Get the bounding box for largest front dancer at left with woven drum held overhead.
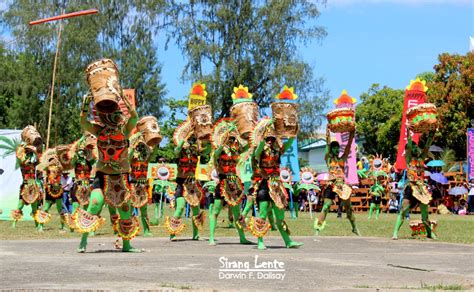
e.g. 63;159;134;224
73;59;141;252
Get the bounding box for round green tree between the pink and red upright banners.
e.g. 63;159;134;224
356;84;404;160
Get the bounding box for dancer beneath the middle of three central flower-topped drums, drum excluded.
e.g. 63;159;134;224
209;119;251;245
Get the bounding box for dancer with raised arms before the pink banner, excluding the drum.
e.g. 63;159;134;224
313;127;360;236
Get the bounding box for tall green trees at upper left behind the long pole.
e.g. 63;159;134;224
0;0;165;145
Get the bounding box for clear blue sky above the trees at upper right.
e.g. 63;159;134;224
159;0;474;107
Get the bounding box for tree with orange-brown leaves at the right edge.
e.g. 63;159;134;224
427;52;474;160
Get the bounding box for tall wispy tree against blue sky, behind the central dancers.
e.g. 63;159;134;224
166;0;327;136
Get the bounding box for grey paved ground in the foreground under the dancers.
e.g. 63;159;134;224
0;237;474;291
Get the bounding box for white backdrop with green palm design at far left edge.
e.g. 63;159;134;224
0;129;32;220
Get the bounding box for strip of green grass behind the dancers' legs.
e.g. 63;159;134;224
0;208;474;244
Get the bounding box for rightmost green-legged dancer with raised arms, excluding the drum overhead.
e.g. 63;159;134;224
392;125;437;240
